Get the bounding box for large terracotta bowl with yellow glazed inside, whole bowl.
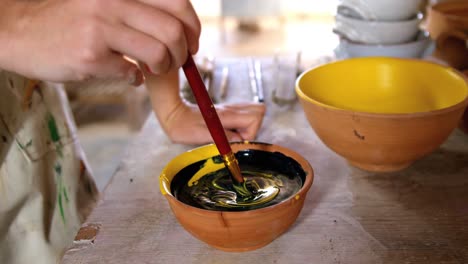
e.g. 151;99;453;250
296;57;468;171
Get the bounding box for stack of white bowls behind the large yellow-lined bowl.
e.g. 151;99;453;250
334;0;431;58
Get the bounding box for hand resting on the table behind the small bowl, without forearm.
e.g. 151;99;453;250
160;102;265;144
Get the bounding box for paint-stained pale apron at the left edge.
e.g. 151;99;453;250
0;70;98;264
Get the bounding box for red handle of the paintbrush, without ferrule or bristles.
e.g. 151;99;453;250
182;55;232;155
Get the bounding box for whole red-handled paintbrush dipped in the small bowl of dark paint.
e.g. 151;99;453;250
182;54;245;187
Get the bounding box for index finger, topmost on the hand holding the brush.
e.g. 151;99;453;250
139;0;201;54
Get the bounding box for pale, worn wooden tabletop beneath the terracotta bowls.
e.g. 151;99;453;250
63;57;468;264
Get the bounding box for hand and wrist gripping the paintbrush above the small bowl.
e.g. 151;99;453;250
0;0;200;82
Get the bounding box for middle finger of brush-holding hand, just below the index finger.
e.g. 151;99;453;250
119;1;188;68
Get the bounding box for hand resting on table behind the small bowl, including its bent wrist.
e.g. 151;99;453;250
145;70;265;144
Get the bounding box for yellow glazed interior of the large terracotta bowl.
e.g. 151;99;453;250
297;58;468;114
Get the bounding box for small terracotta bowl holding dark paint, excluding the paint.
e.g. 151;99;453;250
159;142;314;252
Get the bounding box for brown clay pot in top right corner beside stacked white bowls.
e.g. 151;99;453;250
426;0;468;40
